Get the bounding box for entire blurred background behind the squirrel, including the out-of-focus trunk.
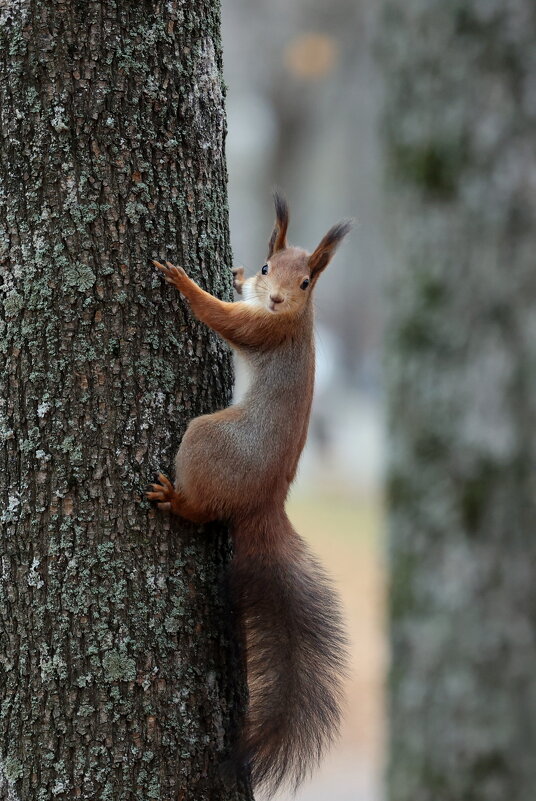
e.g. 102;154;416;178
223;0;536;801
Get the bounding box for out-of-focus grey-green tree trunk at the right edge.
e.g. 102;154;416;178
381;6;536;801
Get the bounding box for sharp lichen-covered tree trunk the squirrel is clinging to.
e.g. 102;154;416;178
0;0;251;801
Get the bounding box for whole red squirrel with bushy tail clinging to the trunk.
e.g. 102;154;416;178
147;194;351;794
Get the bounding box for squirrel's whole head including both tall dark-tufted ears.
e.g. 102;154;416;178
242;192;352;315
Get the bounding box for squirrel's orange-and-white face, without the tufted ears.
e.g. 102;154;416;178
242;247;313;315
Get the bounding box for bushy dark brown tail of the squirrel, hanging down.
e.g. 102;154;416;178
231;514;346;795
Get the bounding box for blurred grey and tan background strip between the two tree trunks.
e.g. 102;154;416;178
223;0;386;801
